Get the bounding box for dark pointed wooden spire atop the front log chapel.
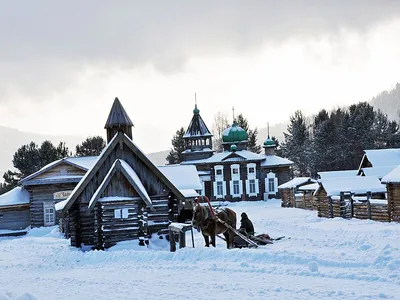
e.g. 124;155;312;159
104;97;133;143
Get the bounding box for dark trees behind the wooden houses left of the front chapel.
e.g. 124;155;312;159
0;136;106;195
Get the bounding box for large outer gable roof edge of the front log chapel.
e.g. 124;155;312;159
63;132;185;214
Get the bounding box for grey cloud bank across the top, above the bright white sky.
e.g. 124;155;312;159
0;0;400;102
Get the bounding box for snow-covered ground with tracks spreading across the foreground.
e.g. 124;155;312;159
0;200;400;300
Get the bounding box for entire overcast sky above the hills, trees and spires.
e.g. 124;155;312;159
0;0;400;152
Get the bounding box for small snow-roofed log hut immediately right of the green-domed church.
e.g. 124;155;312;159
278;177;317;208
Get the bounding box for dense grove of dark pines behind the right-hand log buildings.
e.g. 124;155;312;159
281;102;400;177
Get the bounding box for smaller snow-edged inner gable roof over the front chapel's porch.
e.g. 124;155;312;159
88;159;154;210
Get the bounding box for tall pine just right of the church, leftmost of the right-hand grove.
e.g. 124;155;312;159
281;111;309;176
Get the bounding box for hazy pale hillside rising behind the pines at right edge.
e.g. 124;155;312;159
370;83;400;123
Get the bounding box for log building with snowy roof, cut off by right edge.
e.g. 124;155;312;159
382;165;400;222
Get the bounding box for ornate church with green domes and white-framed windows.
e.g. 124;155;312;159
182;105;293;201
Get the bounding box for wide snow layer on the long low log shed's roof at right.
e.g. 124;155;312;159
319;176;386;196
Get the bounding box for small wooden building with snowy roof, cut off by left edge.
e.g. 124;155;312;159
0;187;30;236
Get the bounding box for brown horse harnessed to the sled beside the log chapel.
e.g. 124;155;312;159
192;204;236;249
